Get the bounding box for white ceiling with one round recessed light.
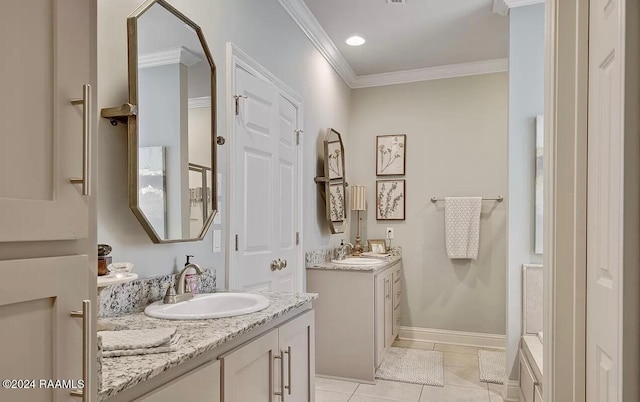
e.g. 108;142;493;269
304;0;509;76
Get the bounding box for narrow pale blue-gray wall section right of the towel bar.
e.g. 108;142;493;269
507;4;544;380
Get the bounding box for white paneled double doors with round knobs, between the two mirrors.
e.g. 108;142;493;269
229;67;299;291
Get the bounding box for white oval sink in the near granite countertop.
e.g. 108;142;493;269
144;293;271;320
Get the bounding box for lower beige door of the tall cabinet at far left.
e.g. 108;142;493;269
0;255;89;402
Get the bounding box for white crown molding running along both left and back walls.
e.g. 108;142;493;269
278;0;510;89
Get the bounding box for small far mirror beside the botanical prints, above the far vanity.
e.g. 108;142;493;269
316;128;347;234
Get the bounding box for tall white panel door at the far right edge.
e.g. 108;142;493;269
586;0;624;402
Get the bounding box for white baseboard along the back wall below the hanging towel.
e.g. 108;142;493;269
398;327;506;349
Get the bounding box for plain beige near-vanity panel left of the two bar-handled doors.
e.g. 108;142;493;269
135;361;220;402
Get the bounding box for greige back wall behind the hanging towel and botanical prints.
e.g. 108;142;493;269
345;73;508;335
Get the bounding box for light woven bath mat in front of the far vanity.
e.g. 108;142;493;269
376;347;444;387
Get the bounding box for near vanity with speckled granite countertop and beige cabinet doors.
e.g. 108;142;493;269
98;292;317;402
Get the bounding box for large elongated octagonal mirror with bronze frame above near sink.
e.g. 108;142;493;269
127;0;217;243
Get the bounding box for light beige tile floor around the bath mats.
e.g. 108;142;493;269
316;341;502;402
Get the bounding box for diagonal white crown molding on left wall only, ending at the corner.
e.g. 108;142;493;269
278;0;356;87
